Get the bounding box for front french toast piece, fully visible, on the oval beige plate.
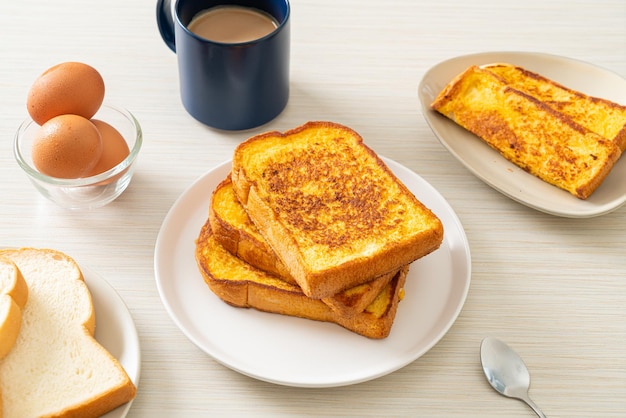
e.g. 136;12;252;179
431;66;621;199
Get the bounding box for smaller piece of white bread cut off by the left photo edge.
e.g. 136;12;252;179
0;257;28;360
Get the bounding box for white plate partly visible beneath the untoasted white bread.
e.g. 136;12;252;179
80;266;141;418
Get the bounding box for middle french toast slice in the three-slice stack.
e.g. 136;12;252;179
209;176;397;316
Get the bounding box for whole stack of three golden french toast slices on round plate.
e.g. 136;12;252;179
195;122;443;339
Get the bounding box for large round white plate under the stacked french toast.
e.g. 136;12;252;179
154;159;471;387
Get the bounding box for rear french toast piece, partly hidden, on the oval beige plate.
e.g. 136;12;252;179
481;63;626;152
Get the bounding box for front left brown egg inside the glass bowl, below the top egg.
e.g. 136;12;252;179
32;115;102;179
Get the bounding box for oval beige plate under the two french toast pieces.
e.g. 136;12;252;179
418;52;626;218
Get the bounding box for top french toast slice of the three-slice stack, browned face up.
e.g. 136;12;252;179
231;122;444;299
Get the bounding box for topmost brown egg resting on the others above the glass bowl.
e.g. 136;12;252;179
26;62;104;125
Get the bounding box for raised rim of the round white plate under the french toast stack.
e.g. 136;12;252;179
154;157;471;388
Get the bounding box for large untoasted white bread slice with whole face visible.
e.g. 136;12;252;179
0;248;136;418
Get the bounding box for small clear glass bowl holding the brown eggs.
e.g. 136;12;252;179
13;104;143;209
